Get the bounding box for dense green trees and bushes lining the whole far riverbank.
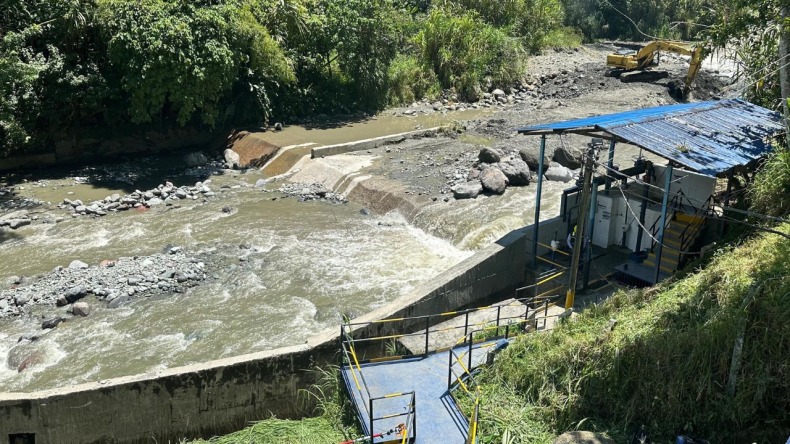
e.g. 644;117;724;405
0;0;779;155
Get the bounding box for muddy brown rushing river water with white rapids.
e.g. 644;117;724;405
0;107;656;391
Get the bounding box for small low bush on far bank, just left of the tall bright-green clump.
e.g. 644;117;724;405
387;54;441;105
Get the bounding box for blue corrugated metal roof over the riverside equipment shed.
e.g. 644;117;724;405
518;99;785;176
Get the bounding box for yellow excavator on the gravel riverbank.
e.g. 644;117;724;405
606;40;703;97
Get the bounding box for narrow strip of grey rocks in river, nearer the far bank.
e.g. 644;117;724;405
58;179;214;217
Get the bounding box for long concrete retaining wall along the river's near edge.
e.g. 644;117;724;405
0;230;527;444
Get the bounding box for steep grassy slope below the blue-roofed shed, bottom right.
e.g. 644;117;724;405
478;224;790;442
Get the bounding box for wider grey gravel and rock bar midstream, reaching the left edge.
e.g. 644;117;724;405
0;247;207;320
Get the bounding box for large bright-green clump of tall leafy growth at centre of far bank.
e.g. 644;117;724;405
415;8;525;100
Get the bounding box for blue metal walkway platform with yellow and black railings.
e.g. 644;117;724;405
341;341;496;444
